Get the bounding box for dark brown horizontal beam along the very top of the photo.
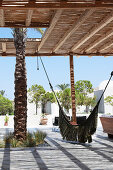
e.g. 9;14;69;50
0;0;113;10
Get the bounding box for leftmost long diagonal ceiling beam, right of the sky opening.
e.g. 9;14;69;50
38;10;62;51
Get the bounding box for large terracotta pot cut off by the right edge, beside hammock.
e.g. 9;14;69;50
100;116;113;138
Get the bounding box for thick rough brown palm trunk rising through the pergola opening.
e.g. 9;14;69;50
14;28;27;140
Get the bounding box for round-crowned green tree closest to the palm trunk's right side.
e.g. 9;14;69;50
28;84;46;114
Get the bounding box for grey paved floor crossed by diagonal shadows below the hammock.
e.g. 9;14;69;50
0;125;113;170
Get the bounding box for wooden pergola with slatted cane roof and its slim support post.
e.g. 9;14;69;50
0;0;113;123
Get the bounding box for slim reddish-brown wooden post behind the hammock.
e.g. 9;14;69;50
70;55;77;124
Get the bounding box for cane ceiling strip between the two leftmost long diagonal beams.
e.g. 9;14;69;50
41;10;84;52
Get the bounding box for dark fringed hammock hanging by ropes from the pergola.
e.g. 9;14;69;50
40;57;113;143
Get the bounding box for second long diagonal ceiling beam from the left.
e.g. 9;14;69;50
53;9;94;52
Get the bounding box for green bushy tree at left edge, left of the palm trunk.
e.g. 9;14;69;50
0;94;13;115
